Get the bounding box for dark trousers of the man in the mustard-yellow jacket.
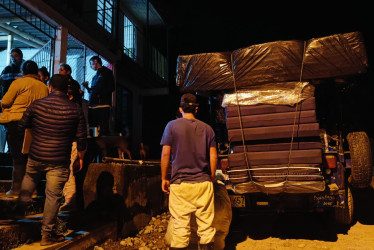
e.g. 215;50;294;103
6;121;27;193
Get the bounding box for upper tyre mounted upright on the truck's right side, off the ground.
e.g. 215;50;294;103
347;132;372;188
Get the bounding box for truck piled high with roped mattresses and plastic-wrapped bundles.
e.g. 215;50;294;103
177;32;372;225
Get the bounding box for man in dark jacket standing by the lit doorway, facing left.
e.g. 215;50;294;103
83;56;115;135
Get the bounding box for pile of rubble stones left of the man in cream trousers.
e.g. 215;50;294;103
94;212;170;250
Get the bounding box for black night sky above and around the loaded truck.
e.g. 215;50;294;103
144;0;374;157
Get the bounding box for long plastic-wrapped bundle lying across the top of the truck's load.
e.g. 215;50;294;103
177;32;368;92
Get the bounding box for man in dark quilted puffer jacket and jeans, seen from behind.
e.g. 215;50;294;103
18;74;87;246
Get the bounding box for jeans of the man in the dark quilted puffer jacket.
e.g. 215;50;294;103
19;158;70;234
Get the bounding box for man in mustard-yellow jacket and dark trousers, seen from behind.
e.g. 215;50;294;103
0;60;48;196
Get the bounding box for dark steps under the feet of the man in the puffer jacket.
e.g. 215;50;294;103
0;212;117;250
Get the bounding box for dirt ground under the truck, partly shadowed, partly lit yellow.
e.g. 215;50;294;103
226;188;374;250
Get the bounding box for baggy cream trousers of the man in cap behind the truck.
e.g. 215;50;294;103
169;181;216;248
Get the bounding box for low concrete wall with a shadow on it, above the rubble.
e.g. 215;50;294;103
83;163;168;235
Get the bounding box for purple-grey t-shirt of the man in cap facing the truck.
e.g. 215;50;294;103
160;118;216;183
